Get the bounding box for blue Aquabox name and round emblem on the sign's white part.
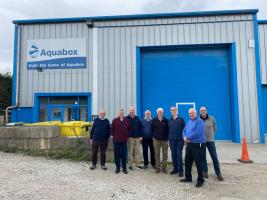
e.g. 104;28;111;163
29;44;78;58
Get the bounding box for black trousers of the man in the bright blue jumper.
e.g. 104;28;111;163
185;143;206;183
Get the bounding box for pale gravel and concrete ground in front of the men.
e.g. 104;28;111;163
0;143;267;200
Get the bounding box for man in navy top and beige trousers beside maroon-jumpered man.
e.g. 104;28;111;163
127;106;143;170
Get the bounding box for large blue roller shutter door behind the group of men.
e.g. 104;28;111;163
140;48;232;140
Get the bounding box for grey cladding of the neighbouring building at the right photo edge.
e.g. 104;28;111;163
259;24;267;84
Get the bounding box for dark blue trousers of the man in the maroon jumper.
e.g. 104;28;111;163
113;142;128;170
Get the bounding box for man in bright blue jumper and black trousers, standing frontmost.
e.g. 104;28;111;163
180;108;206;187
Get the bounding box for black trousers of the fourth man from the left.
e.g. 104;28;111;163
142;138;155;166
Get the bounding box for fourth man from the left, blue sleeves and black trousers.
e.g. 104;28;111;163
142;110;155;169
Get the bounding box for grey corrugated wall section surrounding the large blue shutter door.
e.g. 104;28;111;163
95;15;260;141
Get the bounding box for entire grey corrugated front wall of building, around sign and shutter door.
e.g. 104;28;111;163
19;14;259;141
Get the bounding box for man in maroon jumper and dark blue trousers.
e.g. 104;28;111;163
111;109;131;174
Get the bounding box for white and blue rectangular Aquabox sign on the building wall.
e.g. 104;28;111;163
27;38;86;70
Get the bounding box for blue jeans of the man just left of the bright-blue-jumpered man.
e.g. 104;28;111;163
169;140;184;172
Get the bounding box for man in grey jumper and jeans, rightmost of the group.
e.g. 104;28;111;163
200;106;223;181
